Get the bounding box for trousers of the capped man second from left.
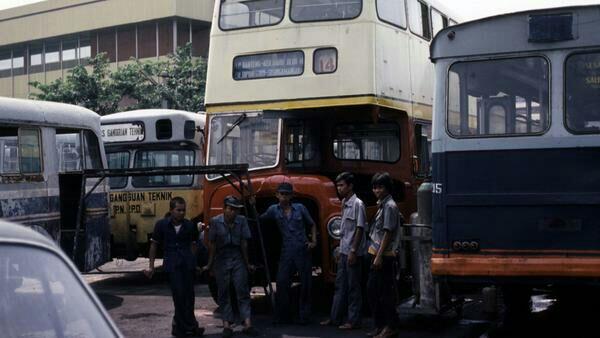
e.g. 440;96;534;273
215;256;250;323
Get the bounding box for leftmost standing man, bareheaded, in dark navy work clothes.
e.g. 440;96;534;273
144;197;204;337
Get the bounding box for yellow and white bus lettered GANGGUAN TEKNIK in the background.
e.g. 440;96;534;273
101;109;205;260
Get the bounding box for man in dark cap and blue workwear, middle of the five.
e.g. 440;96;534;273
260;182;317;324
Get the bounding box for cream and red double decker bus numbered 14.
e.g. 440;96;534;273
204;0;454;281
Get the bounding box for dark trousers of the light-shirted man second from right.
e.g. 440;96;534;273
330;254;362;327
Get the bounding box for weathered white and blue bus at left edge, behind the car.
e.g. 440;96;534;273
0;98;110;271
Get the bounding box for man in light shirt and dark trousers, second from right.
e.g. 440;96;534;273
321;172;366;330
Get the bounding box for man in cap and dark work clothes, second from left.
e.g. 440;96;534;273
203;195;258;337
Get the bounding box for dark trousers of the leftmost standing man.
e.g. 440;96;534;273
169;267;198;333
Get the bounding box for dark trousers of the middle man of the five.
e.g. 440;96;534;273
275;248;312;322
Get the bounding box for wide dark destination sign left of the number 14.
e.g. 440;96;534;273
233;51;304;80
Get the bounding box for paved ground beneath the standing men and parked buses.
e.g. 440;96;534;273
85;259;600;338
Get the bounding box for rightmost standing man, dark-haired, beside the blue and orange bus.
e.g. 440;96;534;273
367;173;401;338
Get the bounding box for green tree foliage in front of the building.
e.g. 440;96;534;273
30;44;206;115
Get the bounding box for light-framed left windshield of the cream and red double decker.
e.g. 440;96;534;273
208;114;279;178
